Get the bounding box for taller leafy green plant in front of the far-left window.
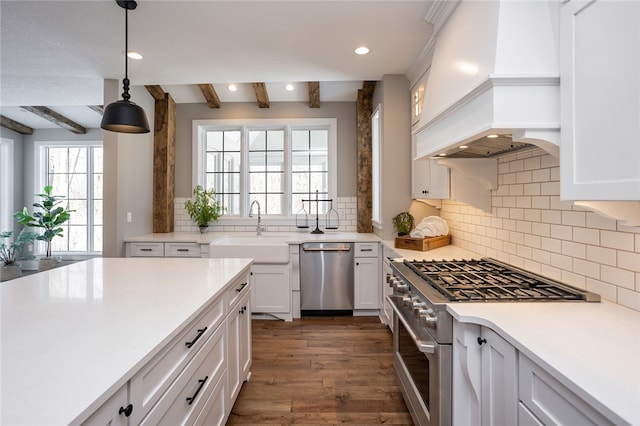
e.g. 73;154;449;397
13;185;73;271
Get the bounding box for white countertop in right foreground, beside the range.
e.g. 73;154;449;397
447;301;640;425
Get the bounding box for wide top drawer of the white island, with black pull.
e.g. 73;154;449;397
131;297;225;424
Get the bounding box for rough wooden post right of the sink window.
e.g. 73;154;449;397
356;81;376;232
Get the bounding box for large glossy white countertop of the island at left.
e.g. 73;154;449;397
0;258;251;426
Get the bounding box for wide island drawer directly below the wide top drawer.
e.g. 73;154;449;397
141;326;226;426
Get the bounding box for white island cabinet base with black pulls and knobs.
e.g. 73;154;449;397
86;274;251;426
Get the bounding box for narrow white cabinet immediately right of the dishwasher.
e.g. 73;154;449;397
353;243;381;314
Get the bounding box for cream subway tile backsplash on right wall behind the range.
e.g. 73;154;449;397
441;149;640;311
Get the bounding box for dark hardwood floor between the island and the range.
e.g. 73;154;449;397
227;317;413;425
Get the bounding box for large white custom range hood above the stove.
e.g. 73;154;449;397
414;0;560;158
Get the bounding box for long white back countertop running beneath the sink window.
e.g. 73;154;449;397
124;231;380;244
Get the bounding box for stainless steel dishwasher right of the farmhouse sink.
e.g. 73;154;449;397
300;243;353;316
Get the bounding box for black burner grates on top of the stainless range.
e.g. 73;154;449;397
404;258;599;302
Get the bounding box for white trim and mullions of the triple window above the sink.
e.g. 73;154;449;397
191;118;338;225
